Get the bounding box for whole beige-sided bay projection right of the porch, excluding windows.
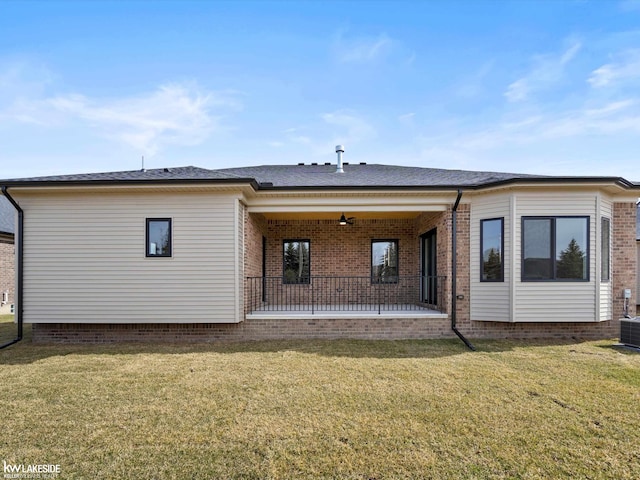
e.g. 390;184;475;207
470;190;616;322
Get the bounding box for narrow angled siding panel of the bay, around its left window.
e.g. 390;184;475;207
470;195;511;322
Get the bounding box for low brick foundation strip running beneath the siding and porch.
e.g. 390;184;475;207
32;318;619;343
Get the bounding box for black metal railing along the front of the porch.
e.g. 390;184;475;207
245;275;446;314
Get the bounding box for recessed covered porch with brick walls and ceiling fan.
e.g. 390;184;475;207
244;192;455;320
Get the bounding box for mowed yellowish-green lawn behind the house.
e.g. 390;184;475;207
0;328;640;479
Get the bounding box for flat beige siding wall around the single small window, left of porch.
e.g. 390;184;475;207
16;189;241;323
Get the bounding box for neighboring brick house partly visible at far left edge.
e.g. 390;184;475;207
0;195;16;314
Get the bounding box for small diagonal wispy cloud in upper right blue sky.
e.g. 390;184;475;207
504;41;582;102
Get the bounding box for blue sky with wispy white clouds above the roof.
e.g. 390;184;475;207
0;0;640;181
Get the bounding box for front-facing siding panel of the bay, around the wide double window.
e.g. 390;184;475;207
514;192;600;322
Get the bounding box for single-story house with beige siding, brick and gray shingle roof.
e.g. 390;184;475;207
0;158;640;342
